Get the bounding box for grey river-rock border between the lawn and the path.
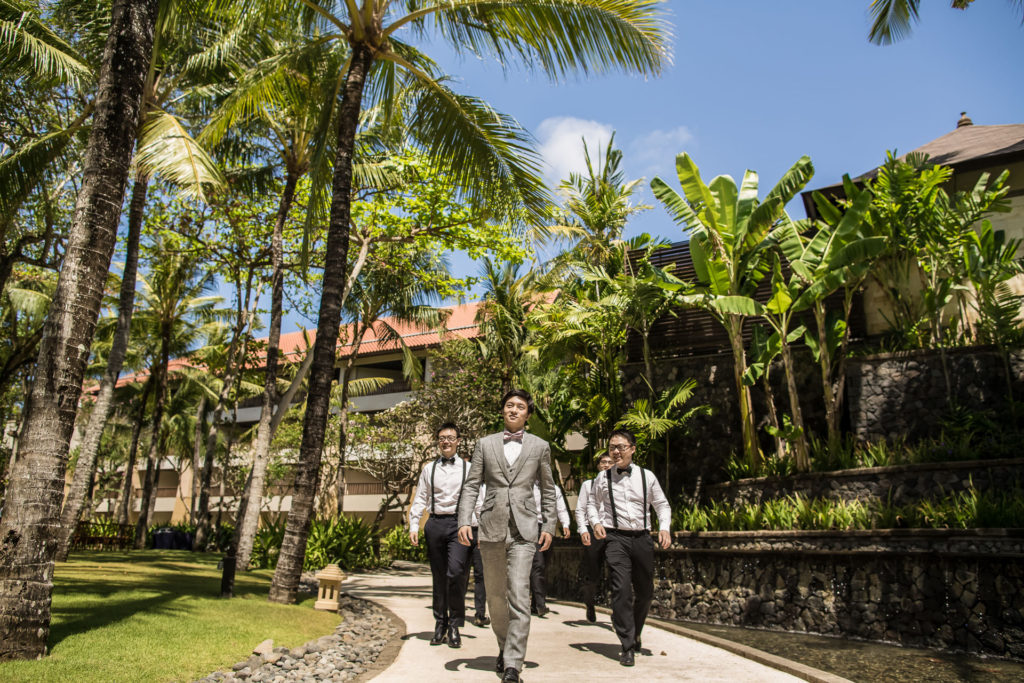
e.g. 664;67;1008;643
199;593;406;683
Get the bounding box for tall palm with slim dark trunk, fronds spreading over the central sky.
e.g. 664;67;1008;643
270;0;666;602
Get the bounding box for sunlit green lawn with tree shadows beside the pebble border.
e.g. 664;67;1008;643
0;550;339;683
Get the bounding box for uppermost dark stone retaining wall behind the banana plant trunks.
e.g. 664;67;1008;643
624;347;1024;496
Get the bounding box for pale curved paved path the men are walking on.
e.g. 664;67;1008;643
342;565;800;683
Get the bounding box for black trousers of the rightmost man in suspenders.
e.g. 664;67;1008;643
604;529;654;650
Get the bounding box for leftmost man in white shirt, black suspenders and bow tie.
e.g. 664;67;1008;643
409;422;469;647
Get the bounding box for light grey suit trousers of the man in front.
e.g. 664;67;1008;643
480;531;537;671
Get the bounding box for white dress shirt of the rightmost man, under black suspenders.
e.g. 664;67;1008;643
587;464;672;531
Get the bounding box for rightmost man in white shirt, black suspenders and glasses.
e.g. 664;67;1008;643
587;429;672;667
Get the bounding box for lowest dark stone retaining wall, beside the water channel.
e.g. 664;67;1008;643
547;529;1024;659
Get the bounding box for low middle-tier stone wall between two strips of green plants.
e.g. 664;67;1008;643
706;458;1024;505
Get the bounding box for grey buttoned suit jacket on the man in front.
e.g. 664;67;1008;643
459;432;556;543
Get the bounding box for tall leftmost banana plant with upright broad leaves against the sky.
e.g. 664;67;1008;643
650;153;814;472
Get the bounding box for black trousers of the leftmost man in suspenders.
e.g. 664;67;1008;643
423;515;469;627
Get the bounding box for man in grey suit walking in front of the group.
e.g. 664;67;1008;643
459;389;556;683
